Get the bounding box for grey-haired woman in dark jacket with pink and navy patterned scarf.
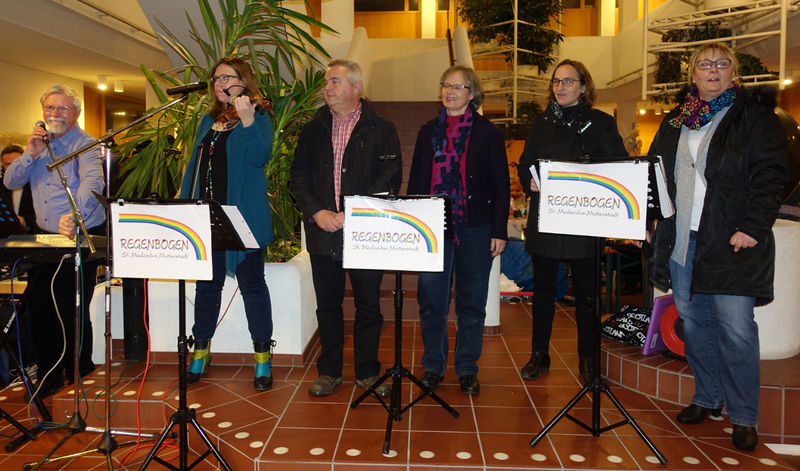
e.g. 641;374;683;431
408;66;510;394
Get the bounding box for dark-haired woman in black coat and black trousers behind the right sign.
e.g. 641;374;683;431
518;59;627;382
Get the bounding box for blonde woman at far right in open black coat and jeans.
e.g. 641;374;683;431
649;43;788;451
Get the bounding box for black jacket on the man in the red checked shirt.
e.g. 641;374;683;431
291;99;403;259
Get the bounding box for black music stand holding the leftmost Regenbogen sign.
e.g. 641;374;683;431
126;199;245;471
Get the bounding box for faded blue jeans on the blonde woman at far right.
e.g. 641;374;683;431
669;232;760;427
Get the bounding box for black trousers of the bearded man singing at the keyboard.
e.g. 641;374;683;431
24;258;100;387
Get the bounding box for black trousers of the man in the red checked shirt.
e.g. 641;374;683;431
311;255;383;379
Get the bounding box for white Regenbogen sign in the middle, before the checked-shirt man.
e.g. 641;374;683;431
343;196;444;272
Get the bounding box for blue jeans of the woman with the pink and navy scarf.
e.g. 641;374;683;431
417;224;492;376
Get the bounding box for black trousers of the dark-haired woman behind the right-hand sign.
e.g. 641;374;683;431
531;254;595;358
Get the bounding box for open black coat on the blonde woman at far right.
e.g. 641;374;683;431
648;87;788;305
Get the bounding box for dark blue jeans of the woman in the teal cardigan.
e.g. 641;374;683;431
192;250;272;342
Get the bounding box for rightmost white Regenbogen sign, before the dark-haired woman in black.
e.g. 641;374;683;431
539;160;648;240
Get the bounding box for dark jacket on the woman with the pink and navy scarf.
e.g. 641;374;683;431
408;112;510;240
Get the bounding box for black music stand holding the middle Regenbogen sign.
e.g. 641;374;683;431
350;195;459;454
